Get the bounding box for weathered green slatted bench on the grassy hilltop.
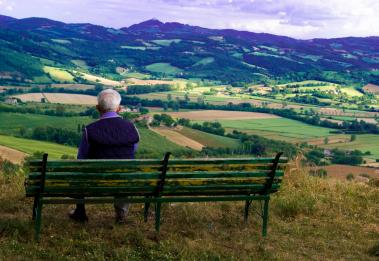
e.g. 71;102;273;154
25;153;287;240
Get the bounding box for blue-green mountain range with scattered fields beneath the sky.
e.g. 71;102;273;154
0;13;379;85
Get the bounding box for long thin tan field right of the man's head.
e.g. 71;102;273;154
167;110;280;121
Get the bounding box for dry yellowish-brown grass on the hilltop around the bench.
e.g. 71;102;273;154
0;162;379;261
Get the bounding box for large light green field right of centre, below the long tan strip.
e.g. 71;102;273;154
215;118;330;138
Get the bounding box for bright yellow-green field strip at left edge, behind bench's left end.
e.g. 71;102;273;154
0;135;78;159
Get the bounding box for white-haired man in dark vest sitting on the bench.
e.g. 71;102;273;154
69;89;139;224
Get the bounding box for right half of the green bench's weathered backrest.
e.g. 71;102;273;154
162;154;287;196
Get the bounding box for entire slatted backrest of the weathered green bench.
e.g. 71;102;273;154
26;154;287;197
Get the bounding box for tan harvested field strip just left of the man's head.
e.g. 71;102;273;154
14;93;97;105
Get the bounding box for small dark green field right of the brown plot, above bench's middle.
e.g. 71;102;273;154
178;127;240;148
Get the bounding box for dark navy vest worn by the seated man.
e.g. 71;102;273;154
86;117;139;159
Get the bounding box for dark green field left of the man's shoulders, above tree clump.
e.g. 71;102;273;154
0;112;93;135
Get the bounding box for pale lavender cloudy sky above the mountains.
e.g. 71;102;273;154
0;0;379;39
